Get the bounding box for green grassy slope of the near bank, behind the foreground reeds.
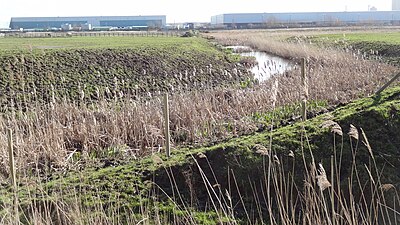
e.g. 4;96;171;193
3;87;400;223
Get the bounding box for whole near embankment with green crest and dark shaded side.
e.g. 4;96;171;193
2;84;400;223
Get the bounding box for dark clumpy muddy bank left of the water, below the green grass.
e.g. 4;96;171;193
0;47;250;105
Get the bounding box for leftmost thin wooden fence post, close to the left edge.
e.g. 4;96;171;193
7;129;19;224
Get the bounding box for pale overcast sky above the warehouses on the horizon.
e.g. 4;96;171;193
0;0;392;27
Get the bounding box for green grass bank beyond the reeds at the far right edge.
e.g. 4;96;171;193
311;32;400;66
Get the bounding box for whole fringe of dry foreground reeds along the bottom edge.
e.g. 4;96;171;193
0;110;400;225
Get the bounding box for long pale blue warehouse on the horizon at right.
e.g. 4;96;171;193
211;11;400;28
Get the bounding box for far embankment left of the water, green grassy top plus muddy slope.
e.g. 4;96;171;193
0;37;250;106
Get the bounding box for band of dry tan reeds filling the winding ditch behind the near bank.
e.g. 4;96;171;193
0;30;395;178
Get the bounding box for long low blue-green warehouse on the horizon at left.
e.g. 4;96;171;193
10;15;166;30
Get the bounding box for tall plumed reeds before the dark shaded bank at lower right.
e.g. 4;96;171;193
161;96;400;224
